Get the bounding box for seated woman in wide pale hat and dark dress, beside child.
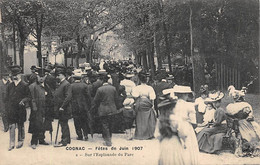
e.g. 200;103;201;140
197;91;227;153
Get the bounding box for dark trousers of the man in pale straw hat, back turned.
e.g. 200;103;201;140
73;115;88;138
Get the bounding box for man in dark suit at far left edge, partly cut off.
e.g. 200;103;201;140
0;73;10;132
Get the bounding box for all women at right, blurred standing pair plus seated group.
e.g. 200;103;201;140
158;85;260;164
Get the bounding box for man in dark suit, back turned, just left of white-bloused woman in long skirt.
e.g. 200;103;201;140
94;73;118;146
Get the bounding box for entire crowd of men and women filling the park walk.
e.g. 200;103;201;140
0;61;260;164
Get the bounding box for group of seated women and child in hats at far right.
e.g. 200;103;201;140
195;86;260;157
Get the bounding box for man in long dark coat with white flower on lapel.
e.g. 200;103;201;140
29;68;53;149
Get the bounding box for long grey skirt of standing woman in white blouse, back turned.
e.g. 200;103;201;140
135;98;156;140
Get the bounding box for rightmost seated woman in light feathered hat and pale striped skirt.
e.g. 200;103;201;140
226;86;260;156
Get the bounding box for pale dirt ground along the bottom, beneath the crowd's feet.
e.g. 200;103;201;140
0;94;260;165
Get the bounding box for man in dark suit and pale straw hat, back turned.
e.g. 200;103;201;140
71;75;91;140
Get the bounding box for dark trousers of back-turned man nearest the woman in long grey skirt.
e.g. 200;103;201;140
101;116;113;143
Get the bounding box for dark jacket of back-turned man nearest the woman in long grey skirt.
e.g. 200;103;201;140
94;83;119;116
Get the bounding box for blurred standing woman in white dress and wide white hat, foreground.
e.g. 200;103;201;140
159;85;199;165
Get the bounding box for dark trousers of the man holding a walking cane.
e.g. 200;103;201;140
60;119;70;145
